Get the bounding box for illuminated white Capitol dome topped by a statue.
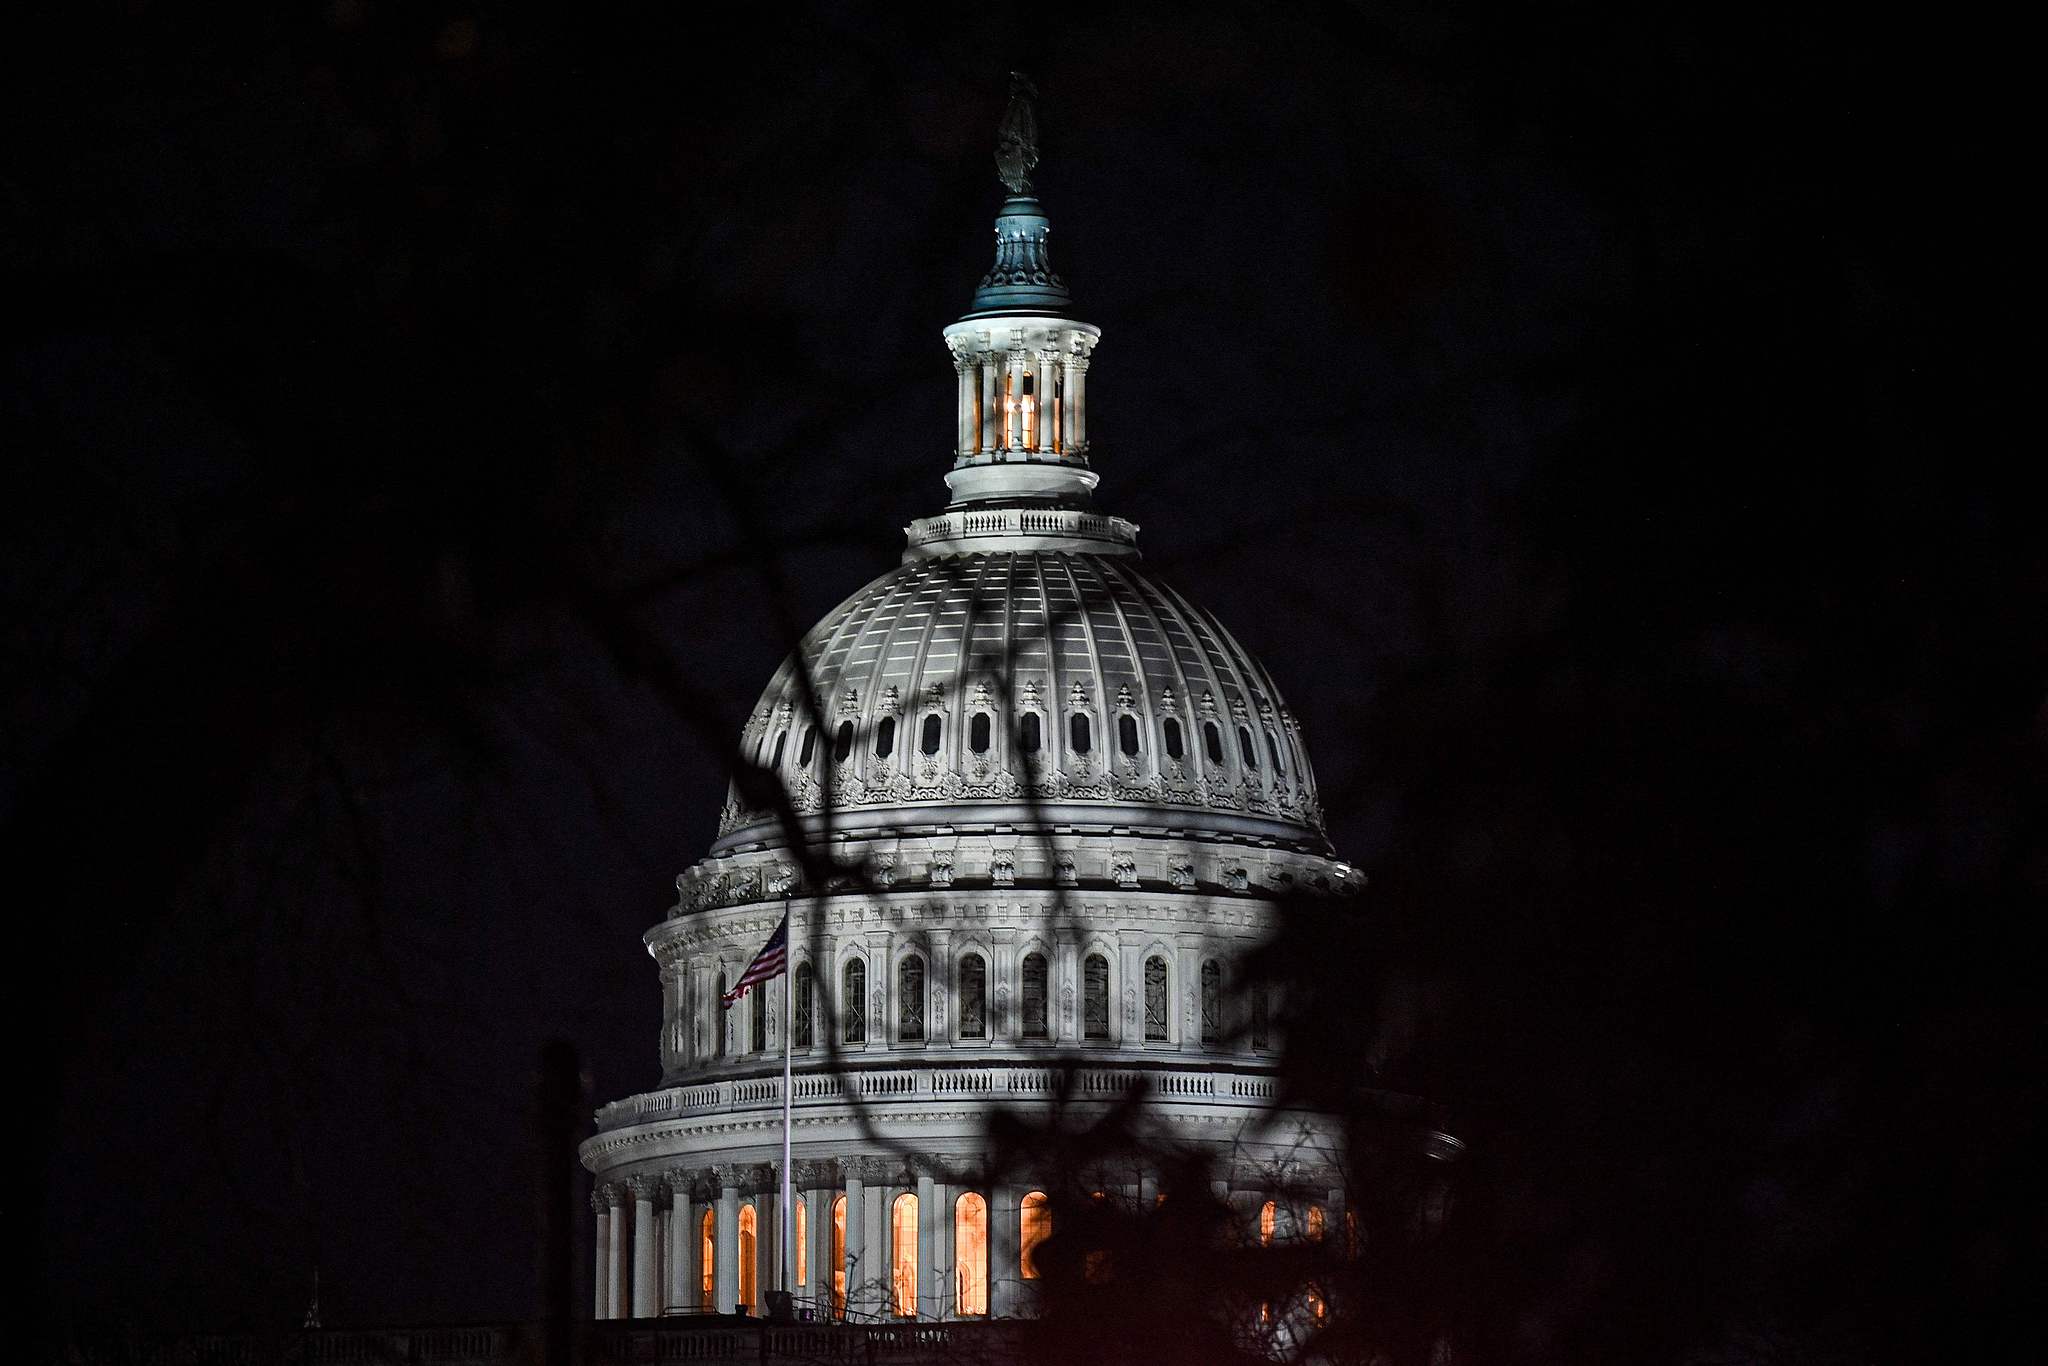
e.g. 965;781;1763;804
582;82;1409;1319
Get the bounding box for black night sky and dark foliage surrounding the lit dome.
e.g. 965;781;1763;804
0;0;2048;1362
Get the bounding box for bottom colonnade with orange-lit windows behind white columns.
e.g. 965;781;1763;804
592;1157;1356;1319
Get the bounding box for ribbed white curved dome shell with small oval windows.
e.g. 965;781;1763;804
721;551;1321;844
